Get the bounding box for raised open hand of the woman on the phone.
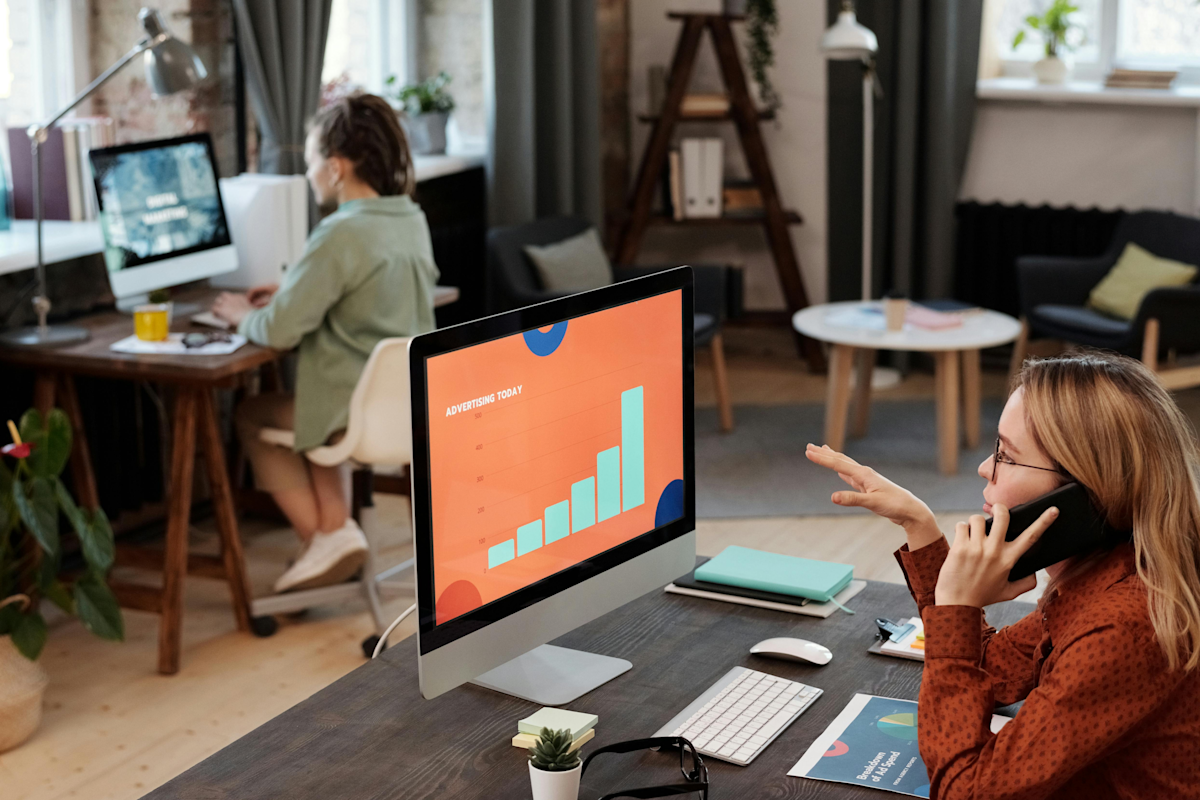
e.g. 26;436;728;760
804;444;942;549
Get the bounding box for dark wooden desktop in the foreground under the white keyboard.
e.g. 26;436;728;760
146;582;1033;800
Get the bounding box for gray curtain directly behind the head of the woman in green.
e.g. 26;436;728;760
233;0;334;175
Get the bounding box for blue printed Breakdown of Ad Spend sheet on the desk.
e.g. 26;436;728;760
787;694;1010;798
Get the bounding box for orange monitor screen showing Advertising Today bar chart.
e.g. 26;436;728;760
427;290;684;625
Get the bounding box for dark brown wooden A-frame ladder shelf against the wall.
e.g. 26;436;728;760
616;12;824;372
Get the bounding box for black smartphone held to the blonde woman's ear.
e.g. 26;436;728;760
988;481;1133;581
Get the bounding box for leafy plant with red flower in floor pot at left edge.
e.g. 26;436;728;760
0;409;125;752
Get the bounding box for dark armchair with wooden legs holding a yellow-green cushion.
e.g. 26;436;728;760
1013;211;1200;389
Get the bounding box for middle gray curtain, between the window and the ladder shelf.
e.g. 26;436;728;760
486;0;602;227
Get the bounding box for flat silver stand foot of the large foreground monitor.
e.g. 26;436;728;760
472;644;634;705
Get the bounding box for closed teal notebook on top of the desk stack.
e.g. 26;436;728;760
695;546;854;603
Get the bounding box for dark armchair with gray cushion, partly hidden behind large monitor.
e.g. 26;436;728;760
487;217;742;432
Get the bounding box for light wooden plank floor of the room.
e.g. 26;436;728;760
0;331;1142;800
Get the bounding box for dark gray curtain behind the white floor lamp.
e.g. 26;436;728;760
828;0;983;300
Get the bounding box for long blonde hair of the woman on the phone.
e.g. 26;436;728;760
1018;350;1200;670
